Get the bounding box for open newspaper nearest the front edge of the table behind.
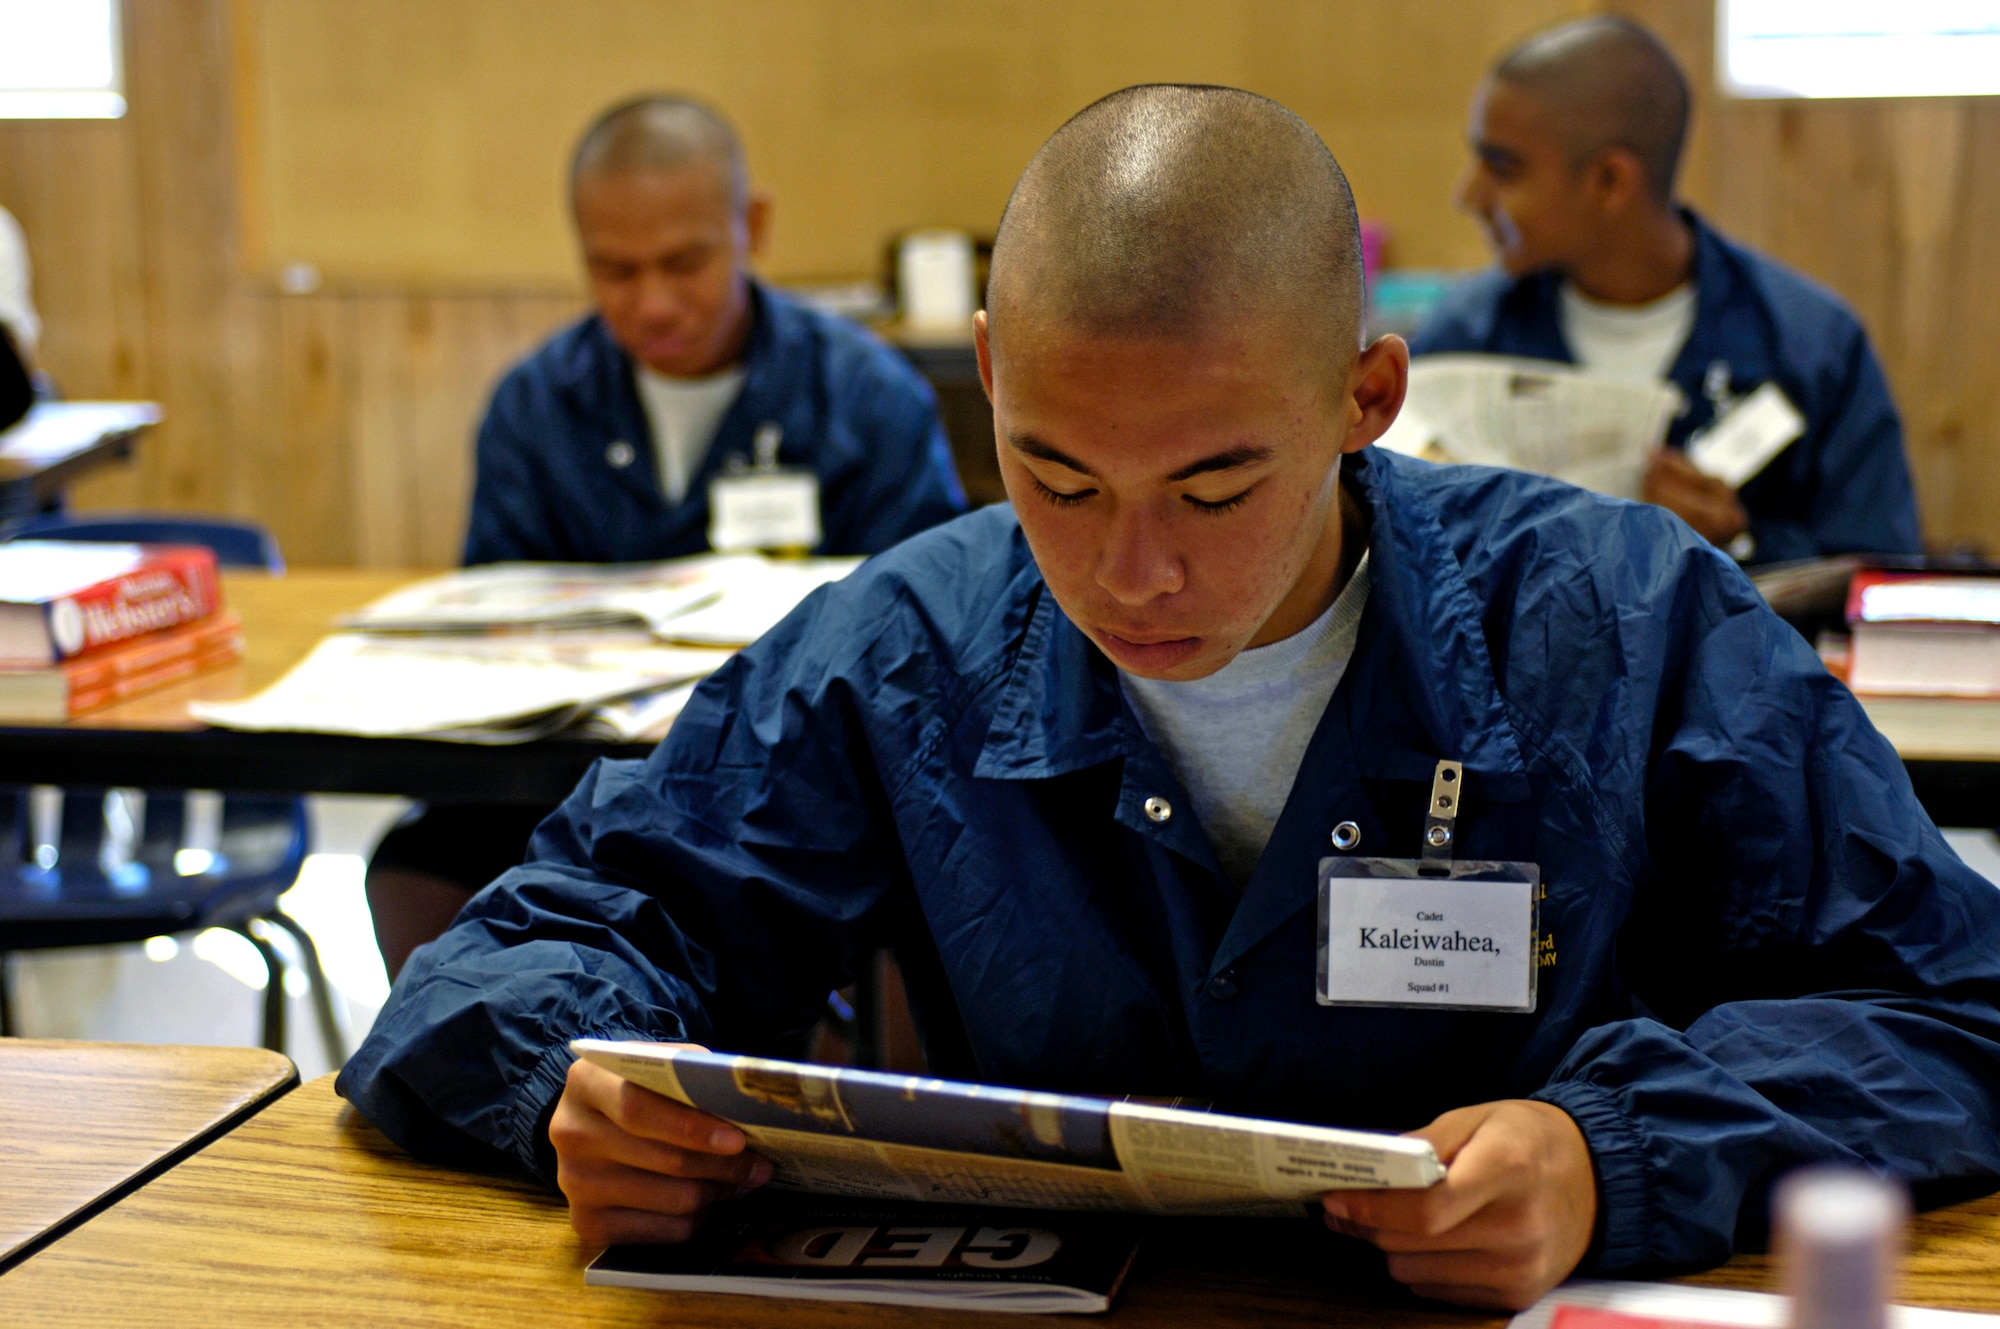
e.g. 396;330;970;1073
188;632;732;743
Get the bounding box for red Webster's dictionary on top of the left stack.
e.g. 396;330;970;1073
0;540;222;667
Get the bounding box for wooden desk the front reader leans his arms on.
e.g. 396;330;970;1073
0;1077;2000;1329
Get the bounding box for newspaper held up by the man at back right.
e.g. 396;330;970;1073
1376;354;1682;498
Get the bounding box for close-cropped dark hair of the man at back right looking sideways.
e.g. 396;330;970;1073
1494;16;1688;202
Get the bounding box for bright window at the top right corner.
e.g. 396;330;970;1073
1716;0;2000;96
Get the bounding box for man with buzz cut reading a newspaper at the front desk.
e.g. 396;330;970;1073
340;86;2000;1307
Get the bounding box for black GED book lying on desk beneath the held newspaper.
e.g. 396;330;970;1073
584;1193;1144;1315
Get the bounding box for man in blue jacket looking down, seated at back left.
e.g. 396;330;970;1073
368;96;966;975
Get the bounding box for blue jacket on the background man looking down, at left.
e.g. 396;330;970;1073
464;282;966;564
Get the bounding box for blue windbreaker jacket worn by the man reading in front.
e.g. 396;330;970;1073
340;448;2000;1271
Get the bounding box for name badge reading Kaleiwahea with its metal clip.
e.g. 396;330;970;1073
1314;761;1542;1013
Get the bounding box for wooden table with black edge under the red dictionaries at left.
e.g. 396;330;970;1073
0;568;652;805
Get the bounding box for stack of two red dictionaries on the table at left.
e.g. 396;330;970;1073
0;540;242;721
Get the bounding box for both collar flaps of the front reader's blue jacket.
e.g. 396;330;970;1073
974;448;1528;799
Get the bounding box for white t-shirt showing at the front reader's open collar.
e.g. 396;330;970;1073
1118;554;1368;891
